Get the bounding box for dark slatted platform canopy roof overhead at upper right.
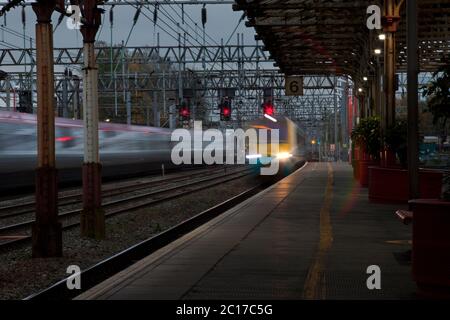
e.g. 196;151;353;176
233;0;450;75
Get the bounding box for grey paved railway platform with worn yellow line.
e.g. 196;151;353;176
76;163;416;300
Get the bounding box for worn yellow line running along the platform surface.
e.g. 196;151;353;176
303;163;333;299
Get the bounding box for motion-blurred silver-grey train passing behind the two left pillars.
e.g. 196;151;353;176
0;111;178;190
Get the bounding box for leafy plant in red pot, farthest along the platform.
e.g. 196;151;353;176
351;117;381;187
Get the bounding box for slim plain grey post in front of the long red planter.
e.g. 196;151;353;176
406;0;419;199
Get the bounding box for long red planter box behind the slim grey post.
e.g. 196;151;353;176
369;167;442;203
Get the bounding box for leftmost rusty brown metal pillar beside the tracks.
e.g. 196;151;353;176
32;0;62;258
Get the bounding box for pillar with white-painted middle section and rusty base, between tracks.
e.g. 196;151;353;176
81;0;105;239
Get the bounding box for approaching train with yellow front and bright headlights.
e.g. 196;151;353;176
247;116;306;176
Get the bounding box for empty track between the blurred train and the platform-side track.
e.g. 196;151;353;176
0;168;253;250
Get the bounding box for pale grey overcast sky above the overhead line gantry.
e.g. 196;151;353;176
0;0;255;47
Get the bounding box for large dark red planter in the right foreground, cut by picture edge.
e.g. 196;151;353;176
409;199;450;298
